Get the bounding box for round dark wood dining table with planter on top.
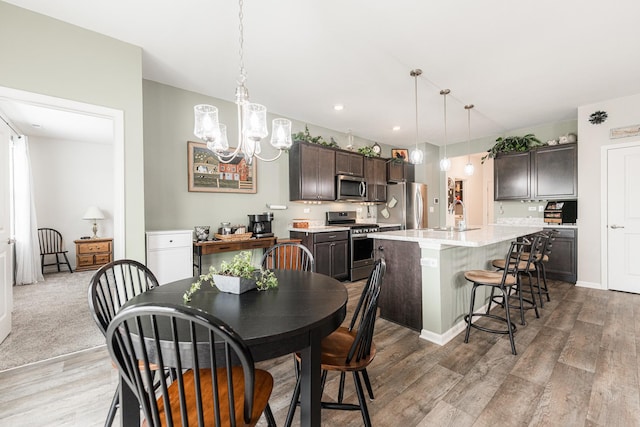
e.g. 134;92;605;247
119;270;347;427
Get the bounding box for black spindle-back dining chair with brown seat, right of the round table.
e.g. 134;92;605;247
285;258;386;427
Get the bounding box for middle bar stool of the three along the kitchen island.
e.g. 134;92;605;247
488;234;542;325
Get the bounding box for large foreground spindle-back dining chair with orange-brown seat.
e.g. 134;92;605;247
107;303;273;426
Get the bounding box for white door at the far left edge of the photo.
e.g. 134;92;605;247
0;126;13;343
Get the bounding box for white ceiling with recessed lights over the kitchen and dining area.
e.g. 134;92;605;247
0;0;640;147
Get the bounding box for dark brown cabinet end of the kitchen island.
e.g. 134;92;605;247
374;239;422;331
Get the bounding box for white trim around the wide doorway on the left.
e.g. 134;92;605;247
0;86;126;259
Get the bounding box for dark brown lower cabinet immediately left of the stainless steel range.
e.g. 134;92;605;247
289;231;349;280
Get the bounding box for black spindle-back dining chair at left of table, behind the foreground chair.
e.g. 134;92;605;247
88;259;158;426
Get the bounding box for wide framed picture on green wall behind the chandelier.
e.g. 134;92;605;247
187;141;258;193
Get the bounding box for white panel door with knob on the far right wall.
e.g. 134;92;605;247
607;145;640;293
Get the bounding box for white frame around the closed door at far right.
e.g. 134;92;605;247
600;139;640;290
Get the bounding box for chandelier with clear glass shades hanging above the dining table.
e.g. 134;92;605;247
193;0;292;164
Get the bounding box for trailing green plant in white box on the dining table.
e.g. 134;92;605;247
183;251;278;302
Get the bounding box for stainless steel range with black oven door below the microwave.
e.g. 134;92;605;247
326;211;378;282
